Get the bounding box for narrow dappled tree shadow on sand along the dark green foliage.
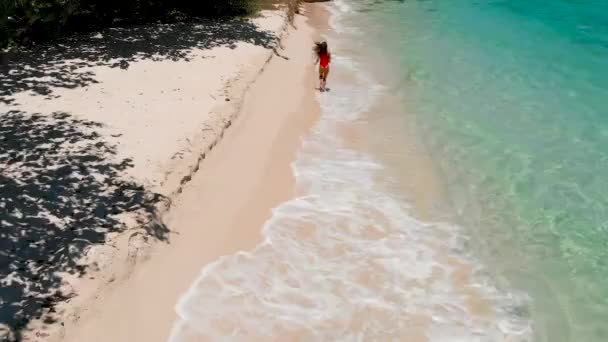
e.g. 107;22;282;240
0;18;277;104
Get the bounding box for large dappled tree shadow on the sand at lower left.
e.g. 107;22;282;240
0;111;169;340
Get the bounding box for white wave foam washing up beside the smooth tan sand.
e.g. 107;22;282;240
170;11;530;342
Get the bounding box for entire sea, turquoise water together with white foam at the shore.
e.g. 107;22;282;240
167;0;608;342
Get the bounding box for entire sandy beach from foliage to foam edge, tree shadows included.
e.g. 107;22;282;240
0;2;318;341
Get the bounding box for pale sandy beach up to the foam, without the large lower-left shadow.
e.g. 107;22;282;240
0;5;318;341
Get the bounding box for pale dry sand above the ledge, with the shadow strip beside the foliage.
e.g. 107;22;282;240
0;11;286;195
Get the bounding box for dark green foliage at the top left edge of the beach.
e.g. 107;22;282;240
0;0;258;48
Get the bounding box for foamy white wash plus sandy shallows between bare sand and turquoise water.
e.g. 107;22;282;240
163;2;532;336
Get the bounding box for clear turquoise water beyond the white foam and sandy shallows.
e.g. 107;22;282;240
340;0;608;341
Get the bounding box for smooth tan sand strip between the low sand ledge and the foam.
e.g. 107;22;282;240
51;5;319;341
